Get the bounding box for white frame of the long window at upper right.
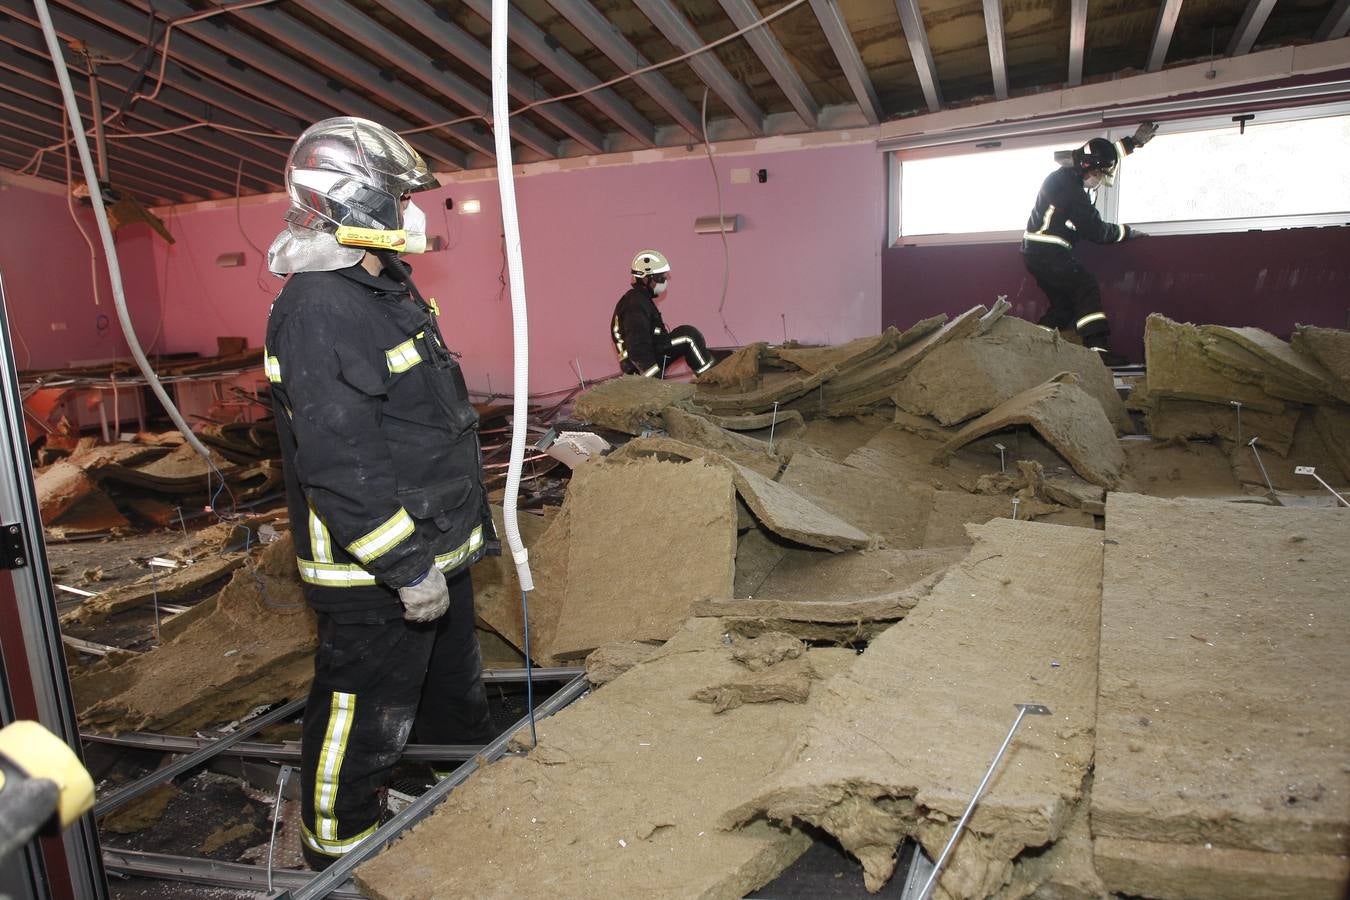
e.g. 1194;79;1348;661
887;101;1350;247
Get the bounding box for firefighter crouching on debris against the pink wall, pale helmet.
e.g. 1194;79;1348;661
609;250;717;378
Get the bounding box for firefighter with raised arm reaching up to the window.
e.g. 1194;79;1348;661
1022;121;1157;364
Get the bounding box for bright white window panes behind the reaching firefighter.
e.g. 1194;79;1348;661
892;109;1350;242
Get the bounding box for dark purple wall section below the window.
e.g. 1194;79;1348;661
882;227;1350;362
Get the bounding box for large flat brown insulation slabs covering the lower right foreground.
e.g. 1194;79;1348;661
358;494;1350;900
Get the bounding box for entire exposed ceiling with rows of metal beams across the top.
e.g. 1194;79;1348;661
0;0;1350;204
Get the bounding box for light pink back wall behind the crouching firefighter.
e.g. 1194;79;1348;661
157;144;886;393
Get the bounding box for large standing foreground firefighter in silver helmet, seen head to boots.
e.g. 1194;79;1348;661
265;117;494;868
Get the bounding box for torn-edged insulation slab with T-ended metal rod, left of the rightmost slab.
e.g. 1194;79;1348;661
724;519;1102;897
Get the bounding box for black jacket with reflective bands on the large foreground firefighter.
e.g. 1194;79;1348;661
265;264;494;615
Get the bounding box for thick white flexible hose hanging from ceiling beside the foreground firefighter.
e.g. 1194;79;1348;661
494;0;535;591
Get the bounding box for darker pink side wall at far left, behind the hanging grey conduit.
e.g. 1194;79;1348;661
0;177;163;368
